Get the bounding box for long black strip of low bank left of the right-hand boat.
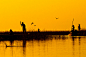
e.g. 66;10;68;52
0;31;69;40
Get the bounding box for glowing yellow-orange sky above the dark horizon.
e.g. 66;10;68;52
0;0;86;31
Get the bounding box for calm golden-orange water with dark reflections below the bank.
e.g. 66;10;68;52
0;35;86;57
